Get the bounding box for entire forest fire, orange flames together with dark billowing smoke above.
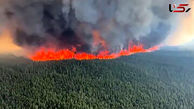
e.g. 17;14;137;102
0;0;172;61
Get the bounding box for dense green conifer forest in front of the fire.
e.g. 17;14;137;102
0;51;194;109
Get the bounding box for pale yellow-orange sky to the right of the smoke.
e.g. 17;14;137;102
166;0;194;46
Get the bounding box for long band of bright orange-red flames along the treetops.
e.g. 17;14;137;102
29;44;159;61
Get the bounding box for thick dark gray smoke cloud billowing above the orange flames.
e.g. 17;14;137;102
0;0;176;52
